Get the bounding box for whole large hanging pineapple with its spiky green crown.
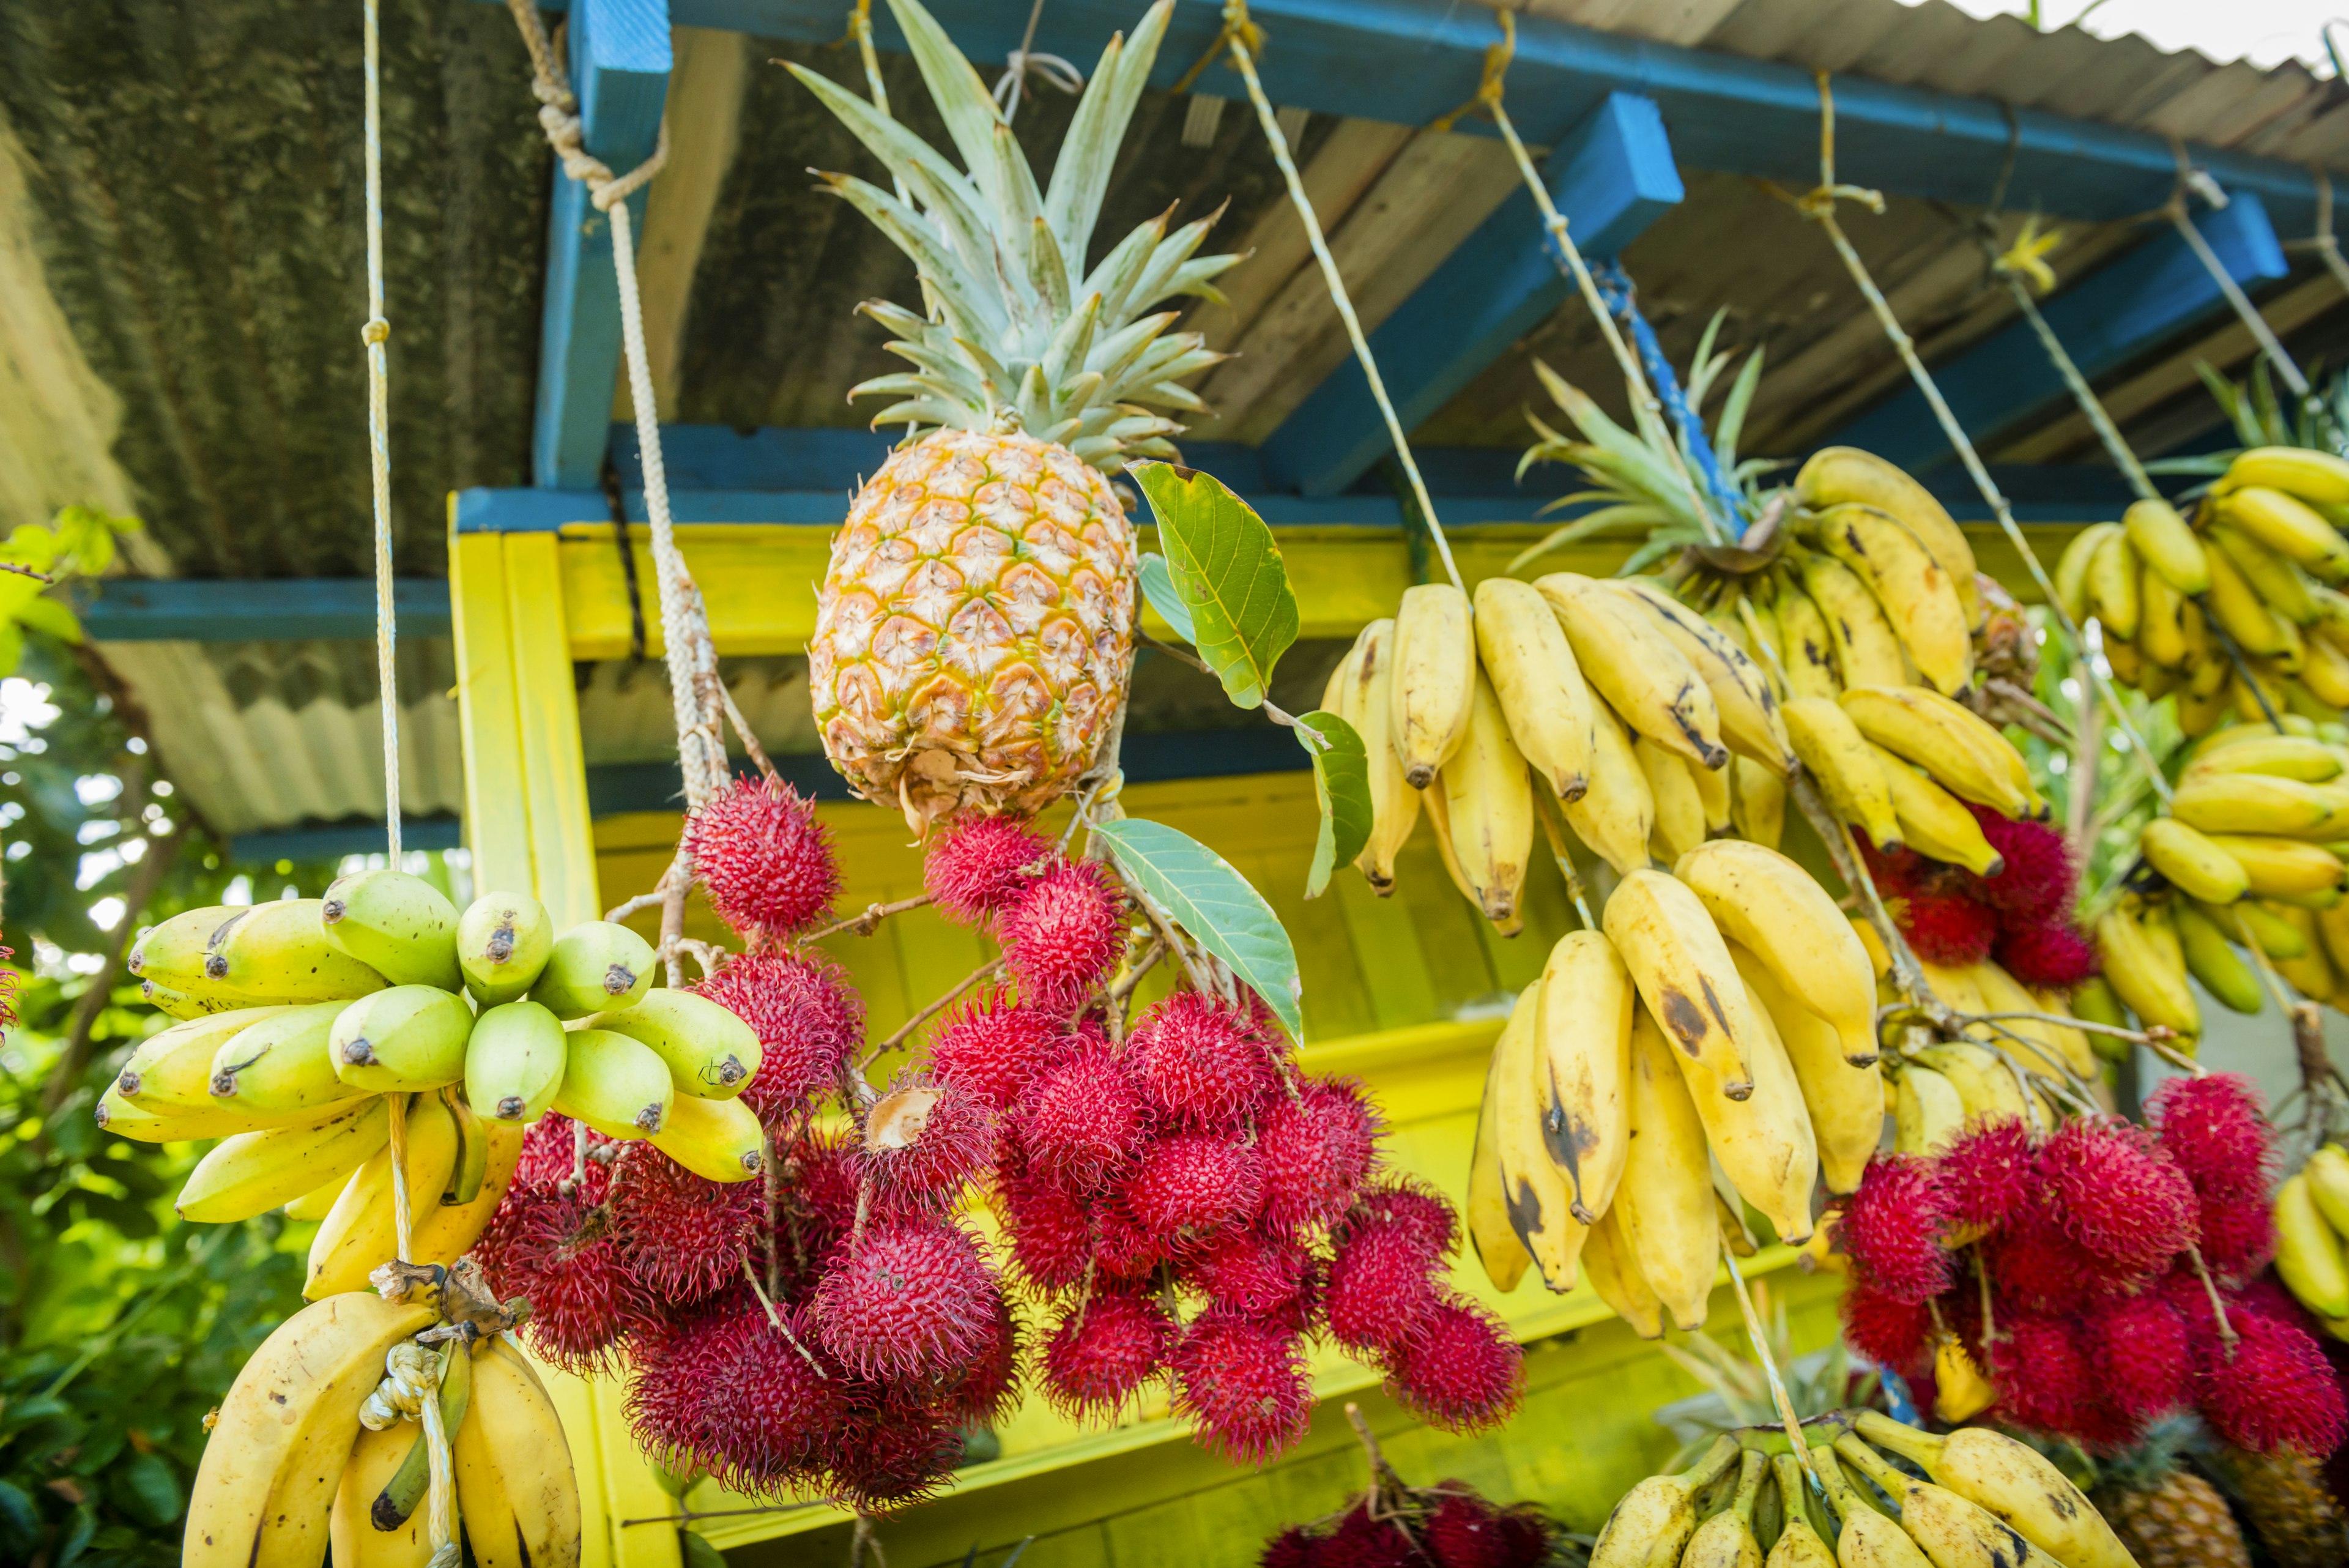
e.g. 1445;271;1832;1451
792;0;1238;832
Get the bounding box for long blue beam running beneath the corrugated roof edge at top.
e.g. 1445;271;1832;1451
472;0;2316;232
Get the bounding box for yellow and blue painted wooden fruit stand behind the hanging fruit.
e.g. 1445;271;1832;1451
37;0;2349;1568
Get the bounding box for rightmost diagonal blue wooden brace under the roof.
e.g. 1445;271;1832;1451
1820;190;2290;468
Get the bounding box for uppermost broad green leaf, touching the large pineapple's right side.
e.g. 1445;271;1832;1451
1127;463;1297;708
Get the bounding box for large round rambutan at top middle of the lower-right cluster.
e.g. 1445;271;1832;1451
2039;1117;2196;1286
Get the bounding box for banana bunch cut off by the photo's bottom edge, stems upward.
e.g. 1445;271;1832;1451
1590;1411;2133;1568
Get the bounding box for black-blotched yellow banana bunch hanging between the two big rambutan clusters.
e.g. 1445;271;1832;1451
1468;839;1884;1337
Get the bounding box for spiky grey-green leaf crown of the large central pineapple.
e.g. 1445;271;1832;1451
789;0;1238;470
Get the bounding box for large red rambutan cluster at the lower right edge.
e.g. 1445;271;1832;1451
1837;1077;2349;1455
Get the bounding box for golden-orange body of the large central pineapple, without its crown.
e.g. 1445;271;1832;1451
808;430;1137;830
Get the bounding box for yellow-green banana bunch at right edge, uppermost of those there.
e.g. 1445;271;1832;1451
2055;447;2349;736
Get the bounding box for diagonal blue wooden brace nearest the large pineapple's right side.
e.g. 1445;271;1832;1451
1264;92;1682;496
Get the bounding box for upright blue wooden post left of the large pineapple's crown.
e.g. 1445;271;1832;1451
531;0;672;489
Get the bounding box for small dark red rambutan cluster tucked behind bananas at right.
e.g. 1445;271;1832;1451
1860;804;2098;987
